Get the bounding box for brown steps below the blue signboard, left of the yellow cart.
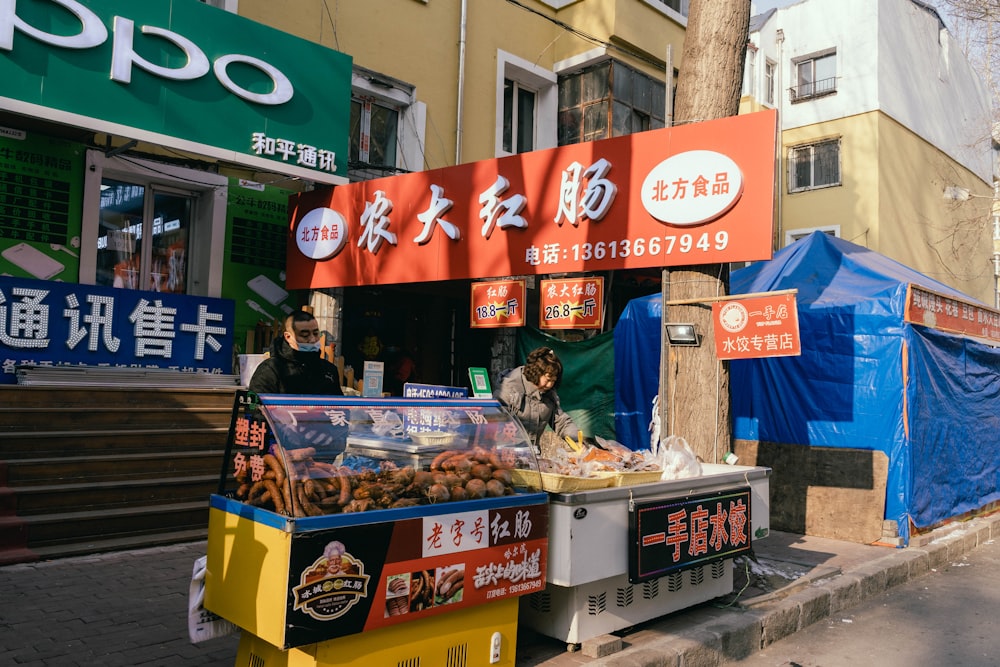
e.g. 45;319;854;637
0;385;238;565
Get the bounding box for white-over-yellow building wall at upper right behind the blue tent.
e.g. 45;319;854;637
741;0;995;304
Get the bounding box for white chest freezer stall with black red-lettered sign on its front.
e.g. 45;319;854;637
521;464;771;648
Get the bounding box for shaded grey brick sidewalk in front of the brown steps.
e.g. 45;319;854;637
0;542;239;667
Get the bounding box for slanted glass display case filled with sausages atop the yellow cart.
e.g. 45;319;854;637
219;392;541;517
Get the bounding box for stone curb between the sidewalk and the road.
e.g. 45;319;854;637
581;514;1000;667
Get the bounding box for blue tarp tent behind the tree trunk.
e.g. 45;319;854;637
615;232;1000;541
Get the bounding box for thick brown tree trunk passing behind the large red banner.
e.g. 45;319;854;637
660;0;750;463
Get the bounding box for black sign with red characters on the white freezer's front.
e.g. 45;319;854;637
628;488;750;584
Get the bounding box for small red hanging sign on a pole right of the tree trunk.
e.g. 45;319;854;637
712;293;802;359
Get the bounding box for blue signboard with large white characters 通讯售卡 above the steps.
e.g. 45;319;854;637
0;277;235;384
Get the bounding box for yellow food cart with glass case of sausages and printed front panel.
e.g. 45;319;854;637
205;392;548;667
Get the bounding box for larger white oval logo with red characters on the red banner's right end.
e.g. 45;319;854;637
642;151;743;227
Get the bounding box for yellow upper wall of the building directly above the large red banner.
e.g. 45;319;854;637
238;0;683;169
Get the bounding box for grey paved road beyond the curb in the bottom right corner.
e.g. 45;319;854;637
728;539;1000;667
